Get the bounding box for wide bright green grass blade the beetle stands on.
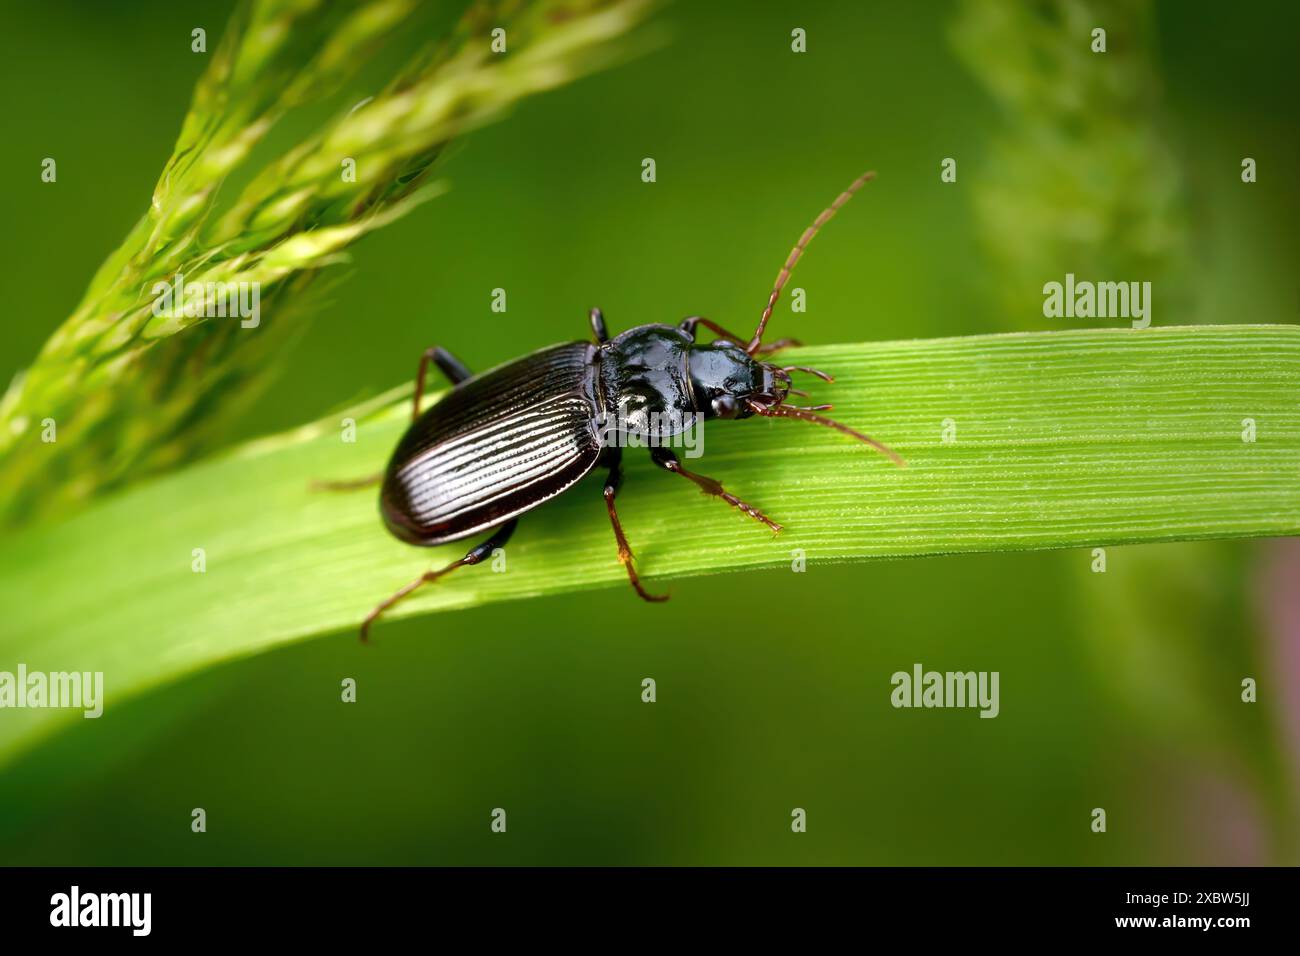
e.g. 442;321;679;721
0;325;1300;756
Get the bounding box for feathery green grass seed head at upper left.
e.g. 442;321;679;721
0;0;650;527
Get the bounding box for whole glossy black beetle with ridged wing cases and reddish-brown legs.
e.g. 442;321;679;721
319;173;904;640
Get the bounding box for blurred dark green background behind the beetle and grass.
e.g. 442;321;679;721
0;0;1300;864
